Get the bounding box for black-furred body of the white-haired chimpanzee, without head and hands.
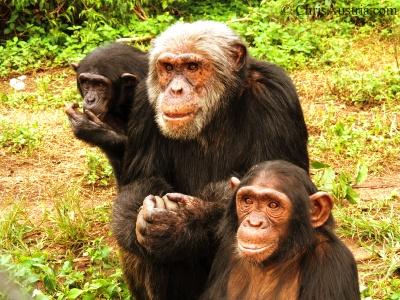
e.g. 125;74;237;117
113;58;309;300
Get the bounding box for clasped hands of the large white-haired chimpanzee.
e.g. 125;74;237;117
136;193;202;253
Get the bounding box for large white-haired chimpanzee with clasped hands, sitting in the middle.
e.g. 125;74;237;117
113;21;308;300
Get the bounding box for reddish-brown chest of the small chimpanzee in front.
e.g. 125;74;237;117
227;257;299;300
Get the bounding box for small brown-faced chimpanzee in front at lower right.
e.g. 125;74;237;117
201;161;360;300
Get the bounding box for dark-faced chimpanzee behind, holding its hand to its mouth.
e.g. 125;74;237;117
66;43;148;181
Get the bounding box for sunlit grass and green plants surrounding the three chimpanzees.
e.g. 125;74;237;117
0;0;400;300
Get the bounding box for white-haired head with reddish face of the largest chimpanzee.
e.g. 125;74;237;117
147;24;247;139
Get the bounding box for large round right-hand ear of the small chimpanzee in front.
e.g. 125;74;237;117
310;192;333;228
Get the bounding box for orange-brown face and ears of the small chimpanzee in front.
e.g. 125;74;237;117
231;170;333;263
